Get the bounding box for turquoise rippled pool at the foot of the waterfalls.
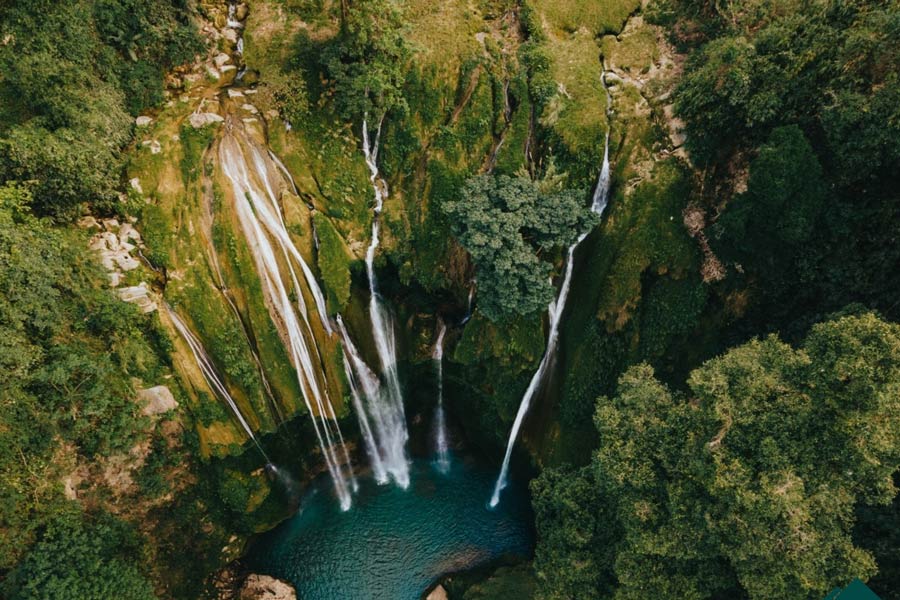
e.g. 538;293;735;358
248;460;534;600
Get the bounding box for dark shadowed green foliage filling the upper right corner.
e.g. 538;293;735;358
651;0;900;339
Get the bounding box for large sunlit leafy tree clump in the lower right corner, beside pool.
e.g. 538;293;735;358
533;313;900;599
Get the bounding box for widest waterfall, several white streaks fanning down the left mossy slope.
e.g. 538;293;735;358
219;129;357;510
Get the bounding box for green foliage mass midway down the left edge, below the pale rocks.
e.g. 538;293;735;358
0;186;162;568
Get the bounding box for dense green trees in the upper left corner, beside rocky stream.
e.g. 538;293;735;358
0;0;202;219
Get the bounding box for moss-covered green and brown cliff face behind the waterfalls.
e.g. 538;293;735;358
85;0;699;592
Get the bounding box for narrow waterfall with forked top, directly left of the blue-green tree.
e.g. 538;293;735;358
362;117;409;488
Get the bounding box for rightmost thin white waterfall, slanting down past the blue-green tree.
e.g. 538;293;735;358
490;67;612;507
